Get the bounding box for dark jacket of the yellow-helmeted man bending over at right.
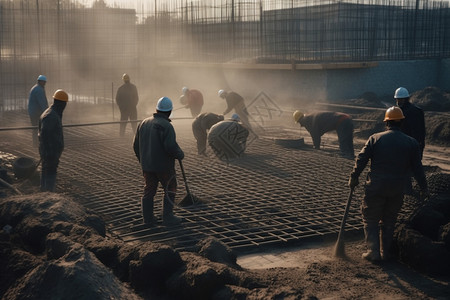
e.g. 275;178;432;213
300;112;351;149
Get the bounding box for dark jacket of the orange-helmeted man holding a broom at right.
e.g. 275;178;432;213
351;127;427;189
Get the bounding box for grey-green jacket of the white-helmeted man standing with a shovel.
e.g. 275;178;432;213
133;113;184;173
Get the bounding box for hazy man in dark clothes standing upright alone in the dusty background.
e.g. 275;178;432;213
116;73;139;137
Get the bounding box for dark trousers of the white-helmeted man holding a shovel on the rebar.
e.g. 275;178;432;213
141;170;177;223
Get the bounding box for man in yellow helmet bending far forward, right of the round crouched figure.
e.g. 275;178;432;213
293;110;355;159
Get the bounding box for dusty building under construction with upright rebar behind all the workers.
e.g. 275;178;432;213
0;0;450;111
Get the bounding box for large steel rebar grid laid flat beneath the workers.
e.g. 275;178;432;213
0;109;370;251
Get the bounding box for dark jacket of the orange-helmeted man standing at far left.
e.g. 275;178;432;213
39;101;66;160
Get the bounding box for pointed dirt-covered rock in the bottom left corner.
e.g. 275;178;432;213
2;244;141;300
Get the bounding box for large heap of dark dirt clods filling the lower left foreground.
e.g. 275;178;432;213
0;193;302;299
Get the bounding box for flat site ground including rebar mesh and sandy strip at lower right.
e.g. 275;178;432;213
0;105;450;299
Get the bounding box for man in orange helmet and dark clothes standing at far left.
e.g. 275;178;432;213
39;90;69;192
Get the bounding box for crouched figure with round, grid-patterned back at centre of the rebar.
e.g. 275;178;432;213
208;114;249;161
